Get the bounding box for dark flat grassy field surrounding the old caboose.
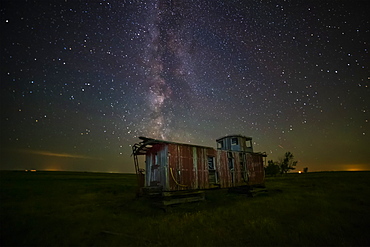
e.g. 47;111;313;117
0;171;370;246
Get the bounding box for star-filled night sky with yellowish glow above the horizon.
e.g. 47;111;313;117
0;0;370;172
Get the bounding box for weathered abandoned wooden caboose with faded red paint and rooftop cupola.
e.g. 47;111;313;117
132;135;266;205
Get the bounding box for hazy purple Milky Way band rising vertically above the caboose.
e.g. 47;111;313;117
144;1;196;139
